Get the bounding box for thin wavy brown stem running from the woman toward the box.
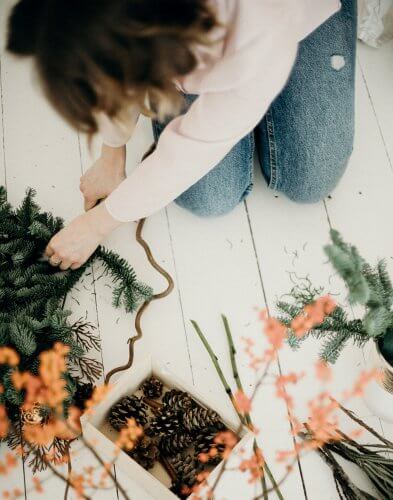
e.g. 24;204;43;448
105;145;174;384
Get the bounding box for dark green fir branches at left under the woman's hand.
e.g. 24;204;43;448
0;186;152;419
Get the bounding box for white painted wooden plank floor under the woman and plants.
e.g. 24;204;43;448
0;2;393;500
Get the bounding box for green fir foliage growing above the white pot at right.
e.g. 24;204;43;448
277;230;393;363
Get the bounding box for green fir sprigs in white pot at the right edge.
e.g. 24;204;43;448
277;230;393;422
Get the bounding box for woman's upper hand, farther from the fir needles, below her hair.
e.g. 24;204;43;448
80;144;126;211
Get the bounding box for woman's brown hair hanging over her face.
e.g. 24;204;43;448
7;0;216;134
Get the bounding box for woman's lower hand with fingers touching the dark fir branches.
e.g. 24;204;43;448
45;203;121;271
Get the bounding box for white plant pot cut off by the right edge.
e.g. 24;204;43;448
364;341;393;423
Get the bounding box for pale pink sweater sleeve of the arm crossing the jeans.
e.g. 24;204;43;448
105;39;297;222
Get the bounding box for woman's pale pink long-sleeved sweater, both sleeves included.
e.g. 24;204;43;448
99;0;340;222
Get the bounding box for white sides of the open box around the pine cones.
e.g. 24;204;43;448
81;359;255;500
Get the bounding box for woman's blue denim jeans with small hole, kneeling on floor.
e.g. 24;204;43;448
153;0;357;216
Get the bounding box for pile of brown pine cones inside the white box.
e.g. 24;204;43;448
108;376;231;498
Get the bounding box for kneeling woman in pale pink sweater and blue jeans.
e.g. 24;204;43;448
8;0;356;269
